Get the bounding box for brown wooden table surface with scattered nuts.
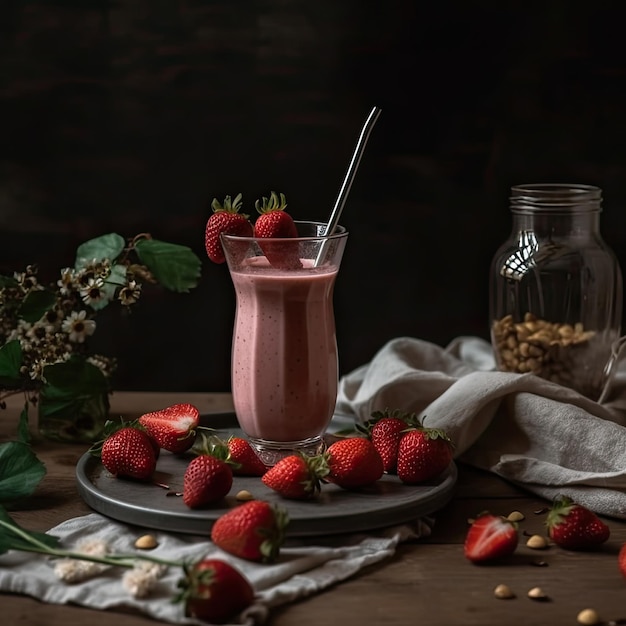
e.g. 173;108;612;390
0;392;626;626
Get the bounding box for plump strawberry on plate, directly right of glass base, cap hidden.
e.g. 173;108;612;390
325;437;384;489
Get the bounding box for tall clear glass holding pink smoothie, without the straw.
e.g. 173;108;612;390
221;222;348;465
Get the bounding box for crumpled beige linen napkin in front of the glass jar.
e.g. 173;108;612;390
337;337;626;518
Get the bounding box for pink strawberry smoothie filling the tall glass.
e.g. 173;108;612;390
231;257;337;442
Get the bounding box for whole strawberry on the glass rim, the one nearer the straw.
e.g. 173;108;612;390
254;191;302;269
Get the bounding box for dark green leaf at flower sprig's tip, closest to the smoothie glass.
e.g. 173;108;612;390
136;239;201;293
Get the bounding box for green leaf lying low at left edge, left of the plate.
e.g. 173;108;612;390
0;441;46;502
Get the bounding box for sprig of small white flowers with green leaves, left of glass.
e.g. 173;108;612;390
0;233;201;432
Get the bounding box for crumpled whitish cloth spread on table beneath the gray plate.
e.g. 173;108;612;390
0;513;432;626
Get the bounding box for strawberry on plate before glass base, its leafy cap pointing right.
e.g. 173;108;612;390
261;454;328;500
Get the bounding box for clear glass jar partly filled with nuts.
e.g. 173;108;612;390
489;184;622;400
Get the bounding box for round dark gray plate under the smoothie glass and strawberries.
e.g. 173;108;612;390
76;413;457;536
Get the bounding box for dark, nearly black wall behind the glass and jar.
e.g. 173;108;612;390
0;0;626;391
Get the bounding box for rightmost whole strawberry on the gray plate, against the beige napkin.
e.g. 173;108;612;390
397;426;452;485
